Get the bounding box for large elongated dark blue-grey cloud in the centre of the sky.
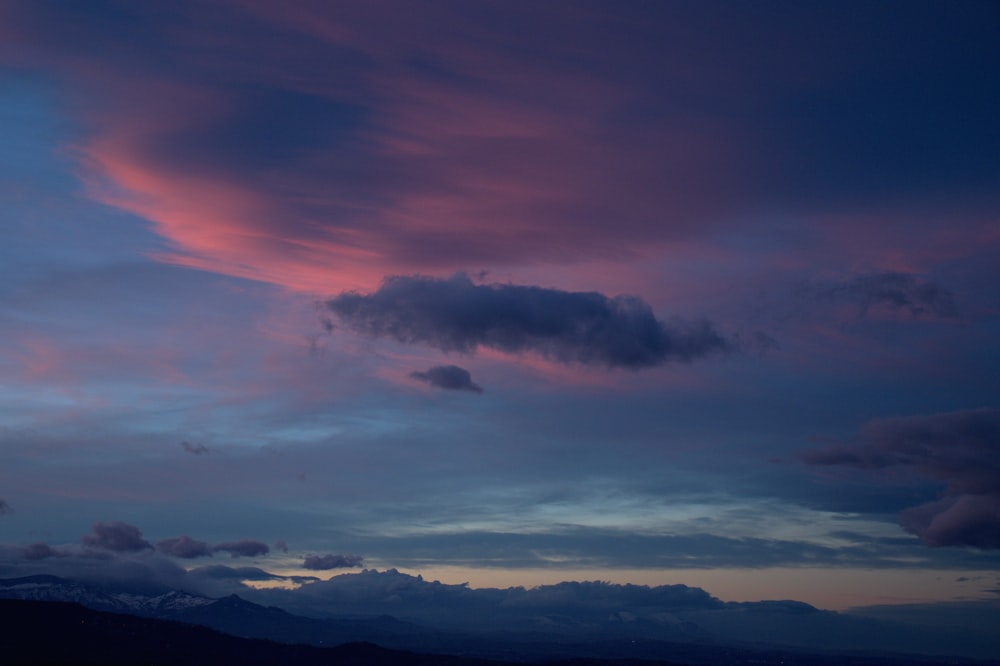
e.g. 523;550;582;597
326;273;736;370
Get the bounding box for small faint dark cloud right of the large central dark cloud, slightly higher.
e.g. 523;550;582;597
804;272;958;318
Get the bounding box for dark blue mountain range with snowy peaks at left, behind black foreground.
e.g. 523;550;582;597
0;575;985;666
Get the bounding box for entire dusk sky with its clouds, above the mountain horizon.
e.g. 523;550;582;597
0;0;1000;609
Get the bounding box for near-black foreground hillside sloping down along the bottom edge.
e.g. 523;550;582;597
0;599;986;666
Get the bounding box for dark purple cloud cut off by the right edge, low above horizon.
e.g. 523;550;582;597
802;409;1000;548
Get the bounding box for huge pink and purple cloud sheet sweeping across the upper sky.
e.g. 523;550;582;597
3;1;997;348
